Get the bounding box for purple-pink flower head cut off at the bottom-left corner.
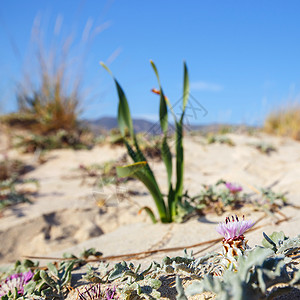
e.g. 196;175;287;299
0;271;33;297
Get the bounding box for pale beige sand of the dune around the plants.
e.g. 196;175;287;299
0;130;300;298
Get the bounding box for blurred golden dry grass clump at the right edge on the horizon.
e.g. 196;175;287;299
264;103;300;140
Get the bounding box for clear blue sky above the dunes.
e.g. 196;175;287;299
0;0;300;125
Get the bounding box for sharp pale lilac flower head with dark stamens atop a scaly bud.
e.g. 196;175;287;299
216;216;255;240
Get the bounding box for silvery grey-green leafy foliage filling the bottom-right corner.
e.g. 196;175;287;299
177;232;300;300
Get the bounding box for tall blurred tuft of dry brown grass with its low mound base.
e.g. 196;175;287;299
0;16;108;151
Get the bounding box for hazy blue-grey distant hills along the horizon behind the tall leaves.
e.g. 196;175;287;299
83;117;255;134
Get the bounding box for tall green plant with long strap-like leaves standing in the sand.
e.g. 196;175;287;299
101;61;189;223
